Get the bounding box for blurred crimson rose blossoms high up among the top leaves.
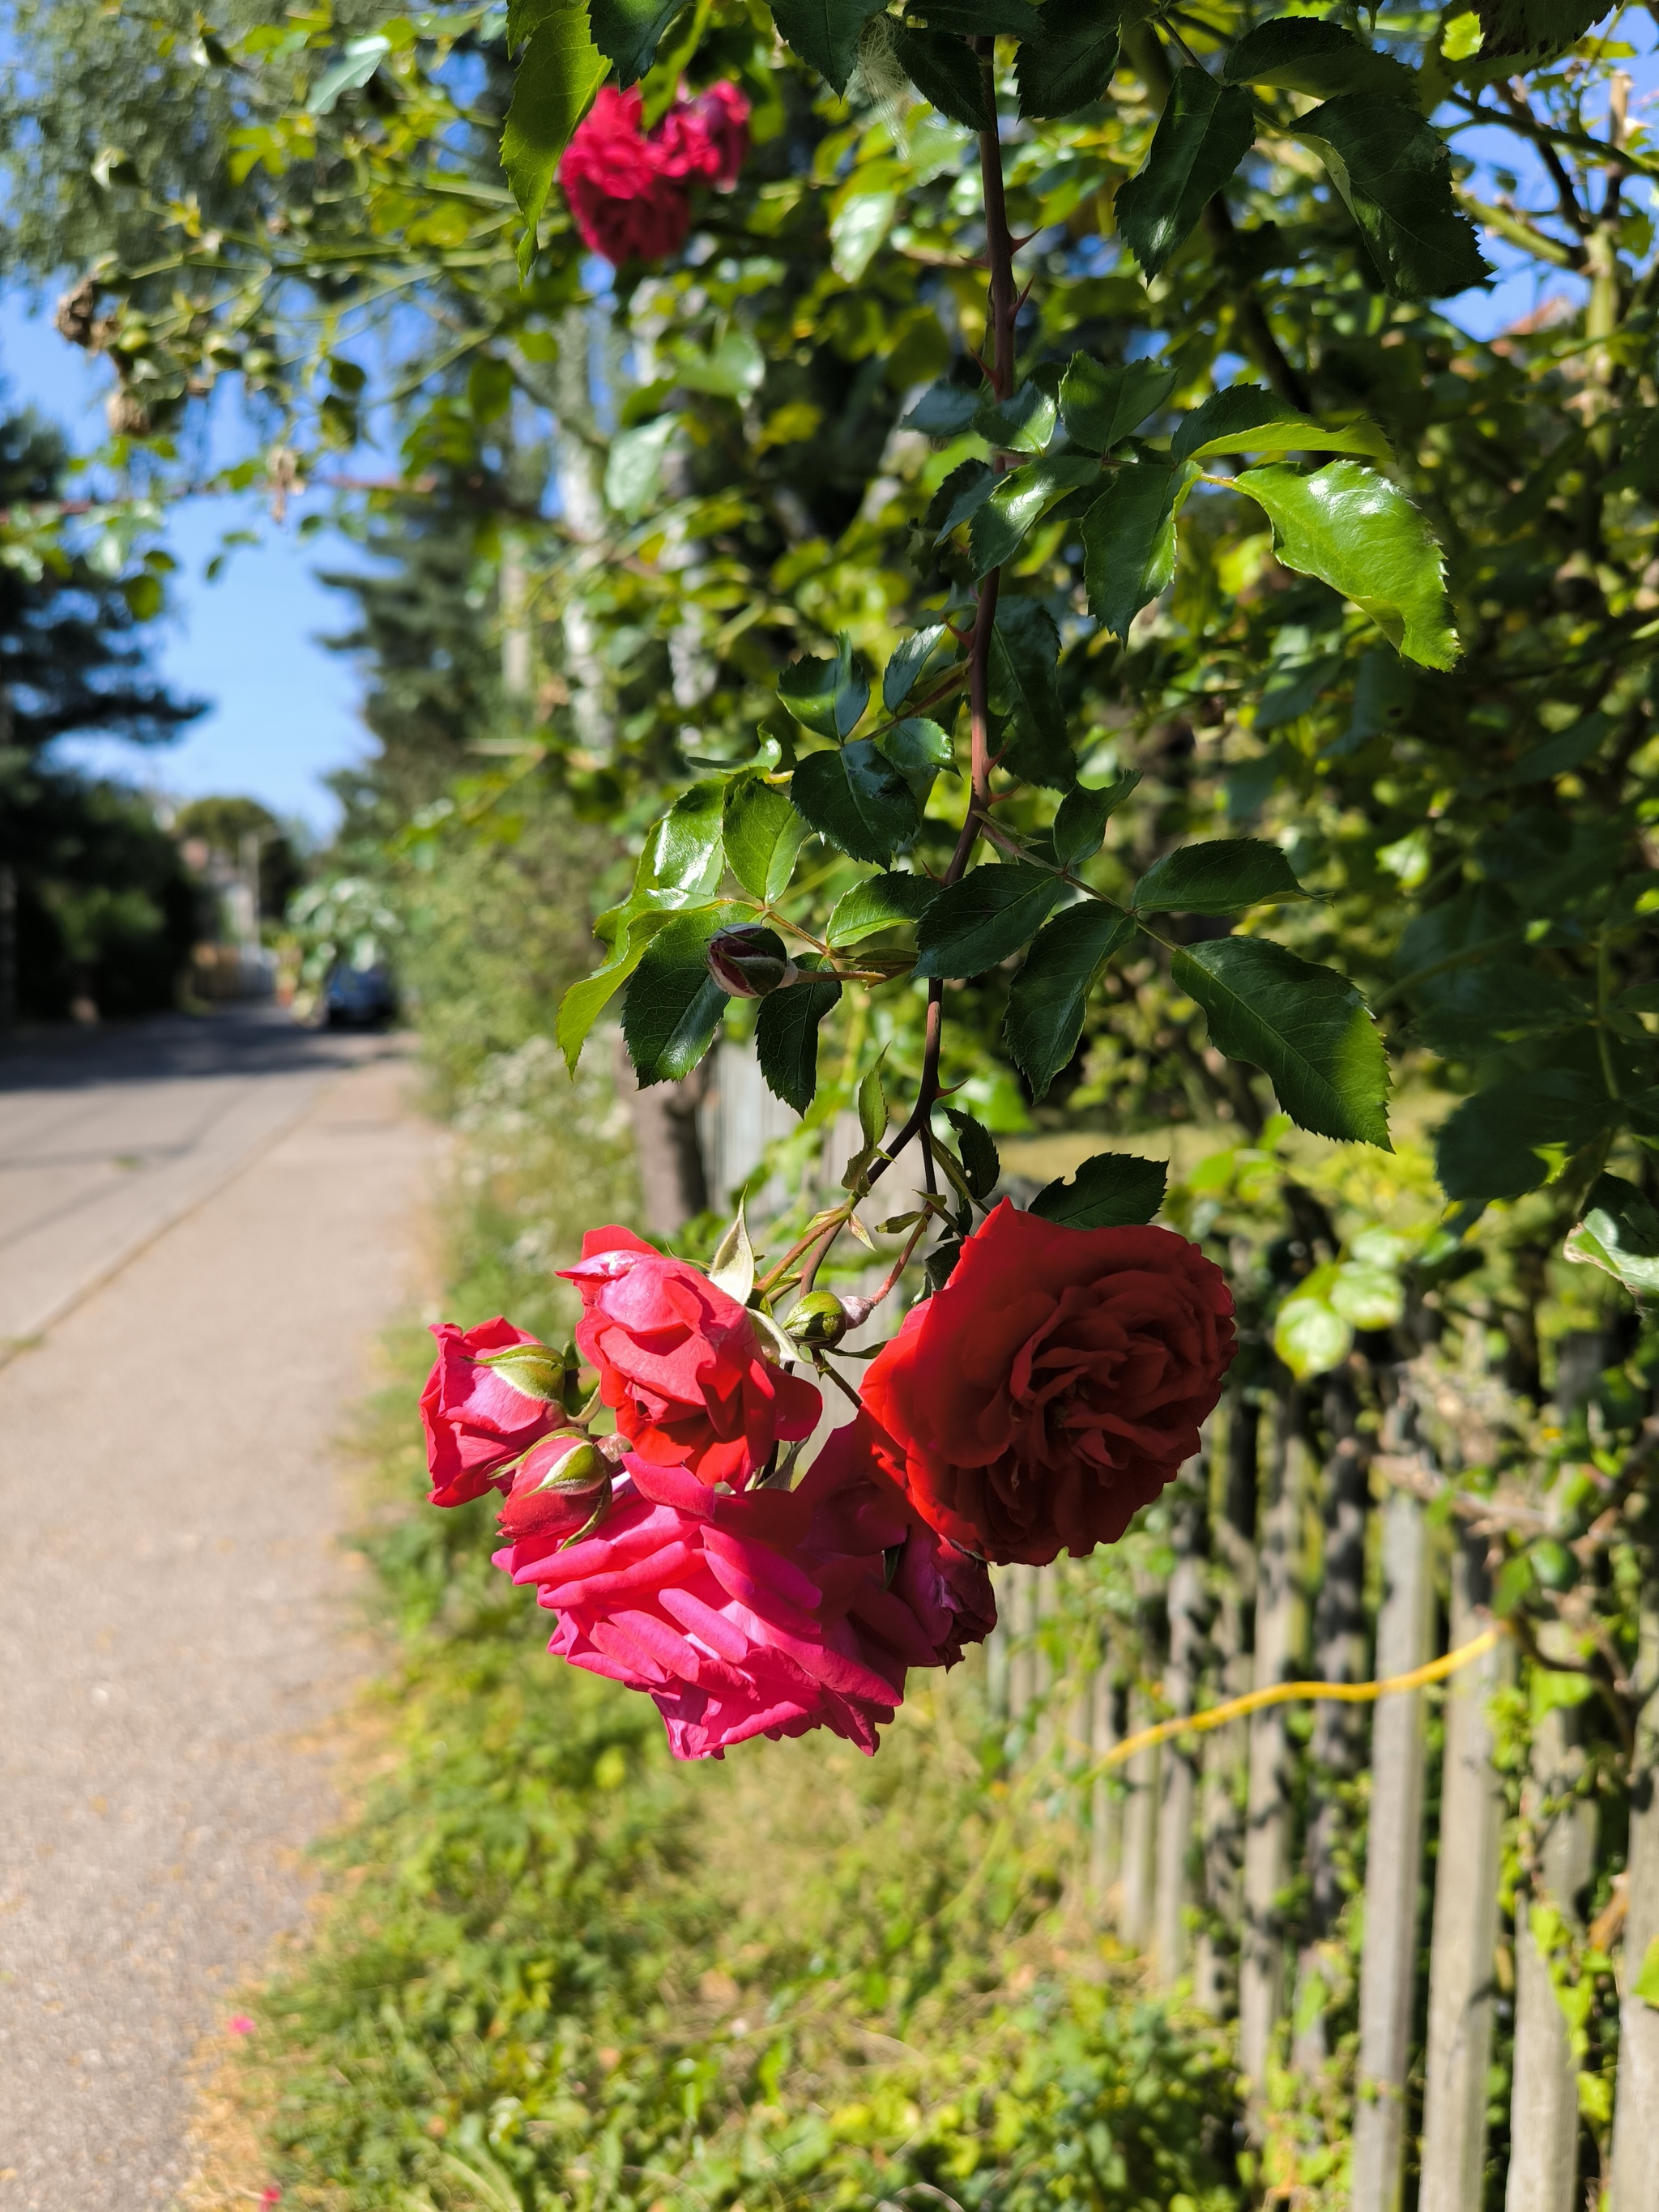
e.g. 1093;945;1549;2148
560;84;750;267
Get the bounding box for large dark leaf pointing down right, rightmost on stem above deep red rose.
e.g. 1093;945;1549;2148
1171;938;1393;1153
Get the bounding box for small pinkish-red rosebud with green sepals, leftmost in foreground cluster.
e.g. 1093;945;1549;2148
420;1316;566;1507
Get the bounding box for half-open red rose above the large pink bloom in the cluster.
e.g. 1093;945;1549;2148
564;1228;823;1489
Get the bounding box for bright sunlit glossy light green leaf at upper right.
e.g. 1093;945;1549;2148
1235;460;1458;668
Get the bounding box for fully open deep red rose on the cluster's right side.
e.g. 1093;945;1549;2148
863;1199;1232;1566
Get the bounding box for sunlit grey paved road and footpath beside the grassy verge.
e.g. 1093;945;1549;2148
0;1017;429;2212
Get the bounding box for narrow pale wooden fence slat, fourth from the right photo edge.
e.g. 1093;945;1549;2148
1354;1491;1433;2212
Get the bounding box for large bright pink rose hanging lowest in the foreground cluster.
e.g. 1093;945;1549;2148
496;1453;936;1758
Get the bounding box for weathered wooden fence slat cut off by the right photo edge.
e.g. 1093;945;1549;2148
1613;1582;1659;2212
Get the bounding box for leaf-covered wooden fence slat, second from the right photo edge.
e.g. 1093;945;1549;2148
1504;1624;1595;2212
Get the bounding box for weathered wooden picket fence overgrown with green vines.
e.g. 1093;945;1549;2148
702;1046;1659;2212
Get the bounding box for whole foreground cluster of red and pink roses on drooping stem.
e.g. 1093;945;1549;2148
420;1201;1232;1758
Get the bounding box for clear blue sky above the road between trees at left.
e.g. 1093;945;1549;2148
0;294;367;836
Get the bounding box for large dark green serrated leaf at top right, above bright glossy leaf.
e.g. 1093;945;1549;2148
1300;93;1491;299
